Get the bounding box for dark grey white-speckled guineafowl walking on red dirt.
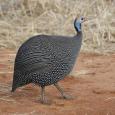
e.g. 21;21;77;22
11;16;85;104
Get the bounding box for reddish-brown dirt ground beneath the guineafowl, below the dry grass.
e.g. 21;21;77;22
0;50;115;115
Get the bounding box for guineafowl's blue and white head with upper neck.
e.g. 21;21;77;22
74;17;86;32
